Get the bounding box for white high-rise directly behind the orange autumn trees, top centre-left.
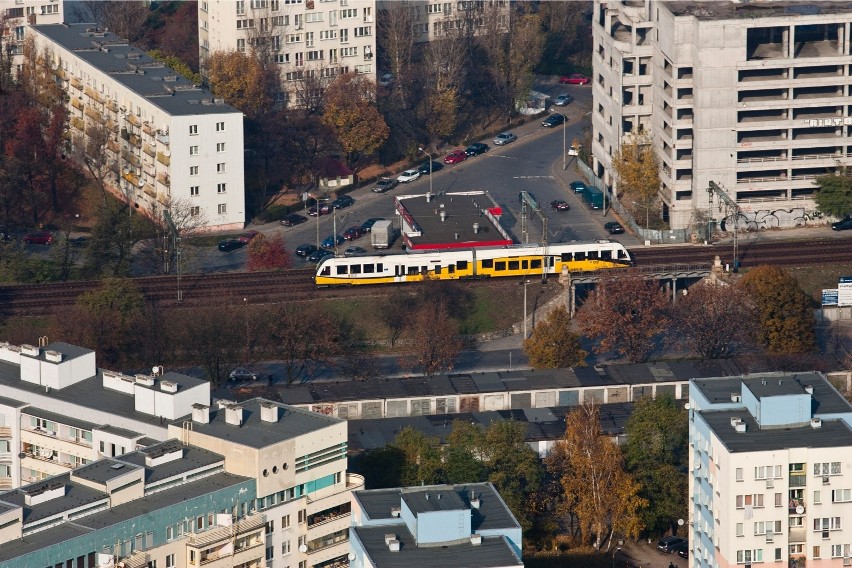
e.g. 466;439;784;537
198;0;377;106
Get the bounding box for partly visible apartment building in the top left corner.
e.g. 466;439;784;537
0;0;65;74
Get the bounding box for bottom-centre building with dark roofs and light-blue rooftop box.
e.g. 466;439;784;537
349;483;524;568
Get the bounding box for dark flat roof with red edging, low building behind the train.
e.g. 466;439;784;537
396;191;512;249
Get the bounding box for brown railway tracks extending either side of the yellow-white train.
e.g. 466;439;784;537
0;239;852;316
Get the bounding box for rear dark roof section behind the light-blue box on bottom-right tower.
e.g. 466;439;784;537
693;372;852;415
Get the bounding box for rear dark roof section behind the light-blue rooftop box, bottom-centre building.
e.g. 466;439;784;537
352;483;520;532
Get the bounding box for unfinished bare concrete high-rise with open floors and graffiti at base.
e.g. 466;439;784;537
592;0;852;229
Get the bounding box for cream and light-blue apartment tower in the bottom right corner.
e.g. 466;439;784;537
688;373;852;568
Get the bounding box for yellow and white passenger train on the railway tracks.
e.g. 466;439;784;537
314;240;632;286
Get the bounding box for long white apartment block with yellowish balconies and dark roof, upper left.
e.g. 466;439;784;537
28;24;245;230
